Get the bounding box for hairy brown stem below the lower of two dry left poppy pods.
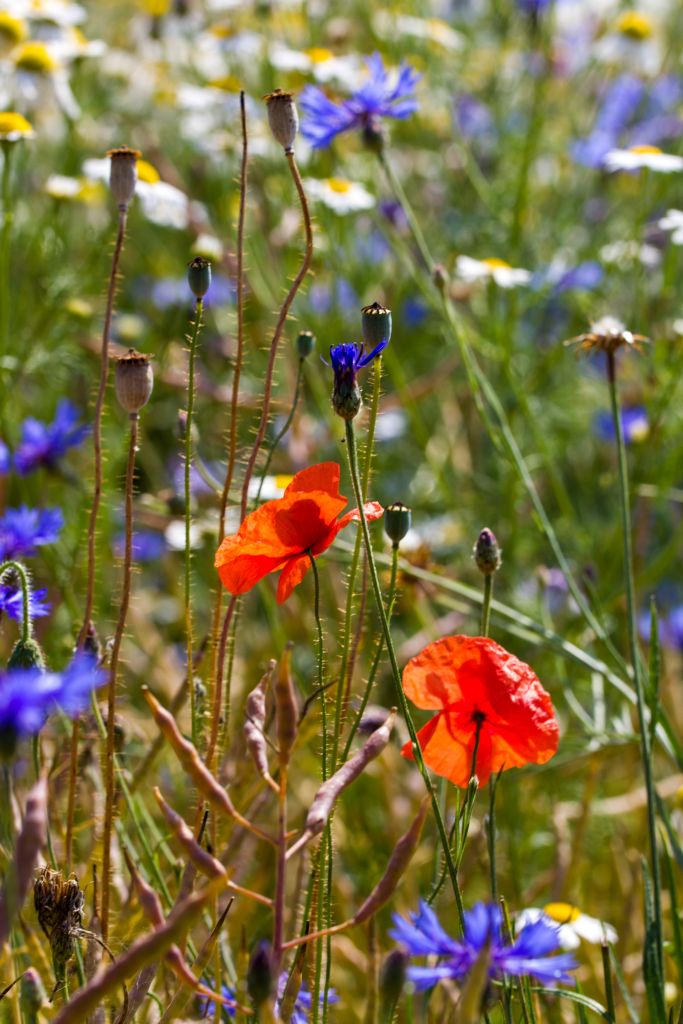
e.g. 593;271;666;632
101;413;139;942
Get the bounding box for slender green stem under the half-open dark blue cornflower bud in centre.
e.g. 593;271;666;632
345;420;465;927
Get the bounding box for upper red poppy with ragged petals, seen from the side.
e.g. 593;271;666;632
214;462;384;604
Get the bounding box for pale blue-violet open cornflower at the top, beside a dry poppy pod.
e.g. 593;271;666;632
299;53;421;150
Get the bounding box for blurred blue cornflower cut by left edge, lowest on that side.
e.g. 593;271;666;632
0;652;106;752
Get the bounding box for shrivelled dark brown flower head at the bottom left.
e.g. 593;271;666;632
33;867;85;983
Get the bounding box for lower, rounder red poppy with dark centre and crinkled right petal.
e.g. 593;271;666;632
401;637;559;786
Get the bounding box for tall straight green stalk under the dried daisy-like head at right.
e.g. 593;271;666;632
607;352;664;979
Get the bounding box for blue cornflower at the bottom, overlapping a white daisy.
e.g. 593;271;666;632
390;900;577;991
